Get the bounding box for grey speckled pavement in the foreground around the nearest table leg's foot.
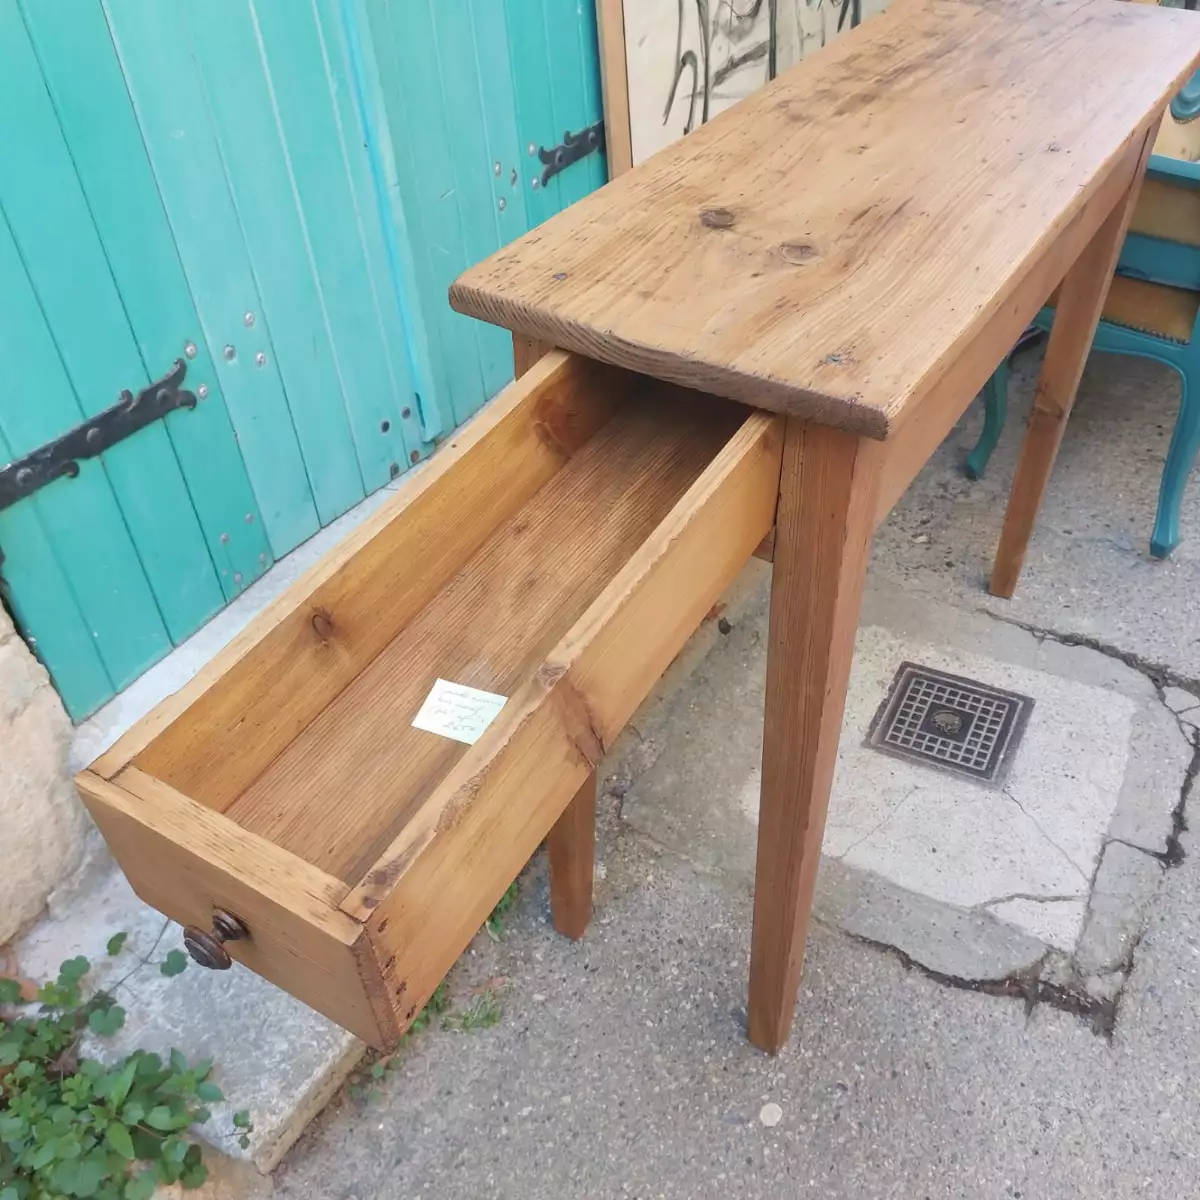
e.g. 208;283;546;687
275;838;1200;1200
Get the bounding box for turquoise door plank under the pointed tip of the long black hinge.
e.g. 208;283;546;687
22;0;270;600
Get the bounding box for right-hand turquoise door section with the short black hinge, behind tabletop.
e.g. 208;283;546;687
357;0;607;430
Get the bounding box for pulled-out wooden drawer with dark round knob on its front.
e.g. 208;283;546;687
78;353;781;1048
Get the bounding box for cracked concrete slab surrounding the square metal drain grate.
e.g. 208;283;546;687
622;578;1200;997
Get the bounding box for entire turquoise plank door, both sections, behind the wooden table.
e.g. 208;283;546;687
0;0;604;719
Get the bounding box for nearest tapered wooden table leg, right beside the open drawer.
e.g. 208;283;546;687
749;418;883;1054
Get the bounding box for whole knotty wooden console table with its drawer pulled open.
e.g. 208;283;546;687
78;0;1200;1051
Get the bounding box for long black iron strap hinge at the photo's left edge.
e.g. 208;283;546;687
0;359;196;520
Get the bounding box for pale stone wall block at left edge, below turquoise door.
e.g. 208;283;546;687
0;607;89;946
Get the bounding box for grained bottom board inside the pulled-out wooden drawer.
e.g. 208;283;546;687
227;380;745;882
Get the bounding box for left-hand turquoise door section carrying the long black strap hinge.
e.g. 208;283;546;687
0;0;270;715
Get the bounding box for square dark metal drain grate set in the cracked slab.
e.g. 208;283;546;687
866;662;1033;784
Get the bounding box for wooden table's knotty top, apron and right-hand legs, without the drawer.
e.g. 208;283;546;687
451;0;1200;1051
